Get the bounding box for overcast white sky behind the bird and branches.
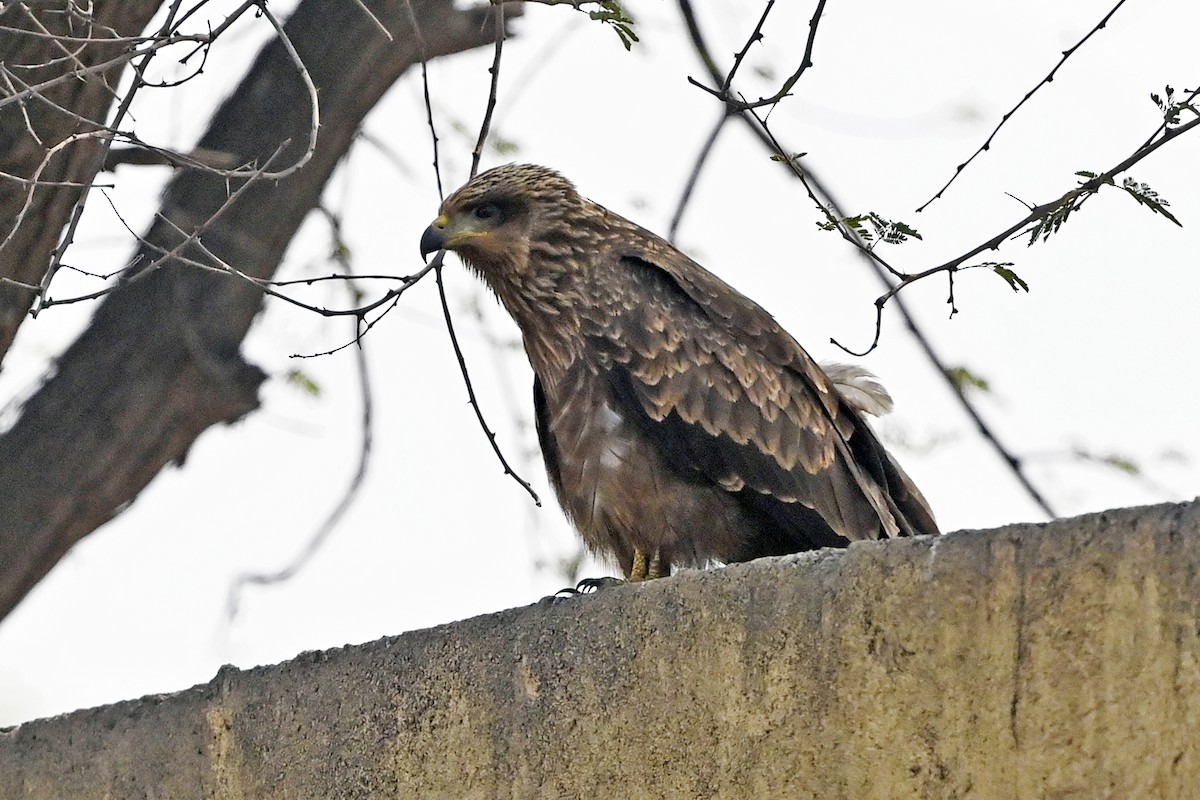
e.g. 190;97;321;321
0;0;1200;724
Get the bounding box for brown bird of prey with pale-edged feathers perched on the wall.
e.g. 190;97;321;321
421;164;938;581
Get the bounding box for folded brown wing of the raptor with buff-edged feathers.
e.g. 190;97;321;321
588;227;937;560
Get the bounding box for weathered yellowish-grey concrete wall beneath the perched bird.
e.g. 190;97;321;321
7;504;1200;800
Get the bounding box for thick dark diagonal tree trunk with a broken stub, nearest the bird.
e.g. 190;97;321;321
0;0;511;616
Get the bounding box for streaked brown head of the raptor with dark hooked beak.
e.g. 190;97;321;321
421;164;583;283
